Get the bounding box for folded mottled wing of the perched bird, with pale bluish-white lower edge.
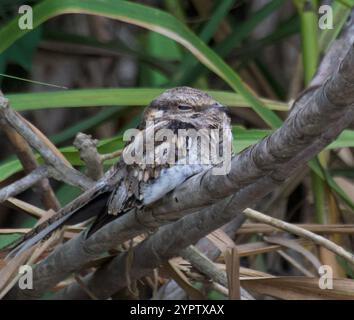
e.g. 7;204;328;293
87;120;210;237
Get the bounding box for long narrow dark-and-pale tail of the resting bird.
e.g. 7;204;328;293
0;183;110;259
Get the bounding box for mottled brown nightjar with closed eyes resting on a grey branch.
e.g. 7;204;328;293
2;87;232;257
